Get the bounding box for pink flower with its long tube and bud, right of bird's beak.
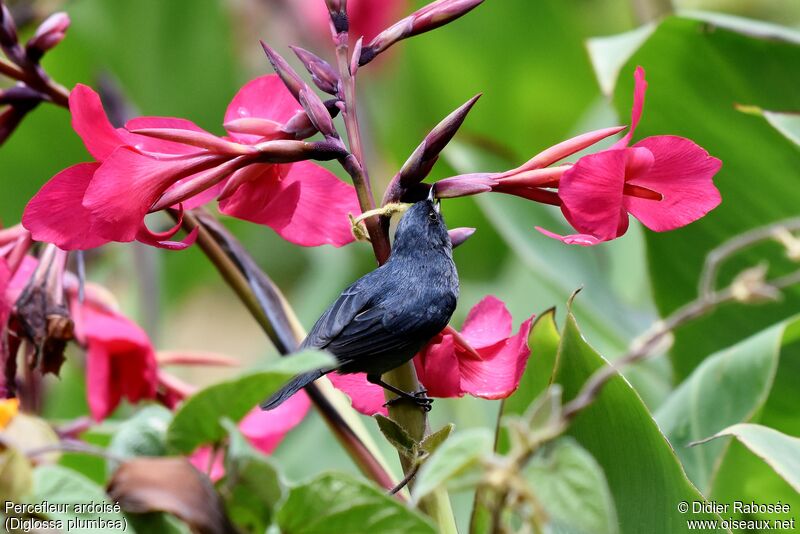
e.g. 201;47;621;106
436;67;722;246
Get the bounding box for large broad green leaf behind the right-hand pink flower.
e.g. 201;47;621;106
615;17;800;379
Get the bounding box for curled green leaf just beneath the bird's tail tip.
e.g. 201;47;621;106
167;350;333;454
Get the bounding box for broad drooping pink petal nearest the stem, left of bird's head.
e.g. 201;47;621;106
220;161;361;247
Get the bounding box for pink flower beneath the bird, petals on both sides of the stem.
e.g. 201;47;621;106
328;296;533;415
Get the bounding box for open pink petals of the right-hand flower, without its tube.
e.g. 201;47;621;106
539;67;722;245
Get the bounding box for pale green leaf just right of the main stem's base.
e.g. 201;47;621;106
411;428;492;502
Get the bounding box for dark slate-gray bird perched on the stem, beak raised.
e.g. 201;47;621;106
261;195;458;410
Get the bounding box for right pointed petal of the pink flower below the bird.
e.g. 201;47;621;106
459;317;533;399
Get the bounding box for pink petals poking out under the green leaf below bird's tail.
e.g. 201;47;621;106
189;391;311;482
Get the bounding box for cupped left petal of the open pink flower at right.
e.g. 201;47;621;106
558;150;628;241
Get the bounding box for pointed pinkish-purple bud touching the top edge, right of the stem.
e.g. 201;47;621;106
359;0;483;66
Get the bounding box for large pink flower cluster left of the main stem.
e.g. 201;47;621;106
23;75;358;249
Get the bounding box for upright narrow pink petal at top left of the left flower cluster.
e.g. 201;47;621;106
69;83;124;161
